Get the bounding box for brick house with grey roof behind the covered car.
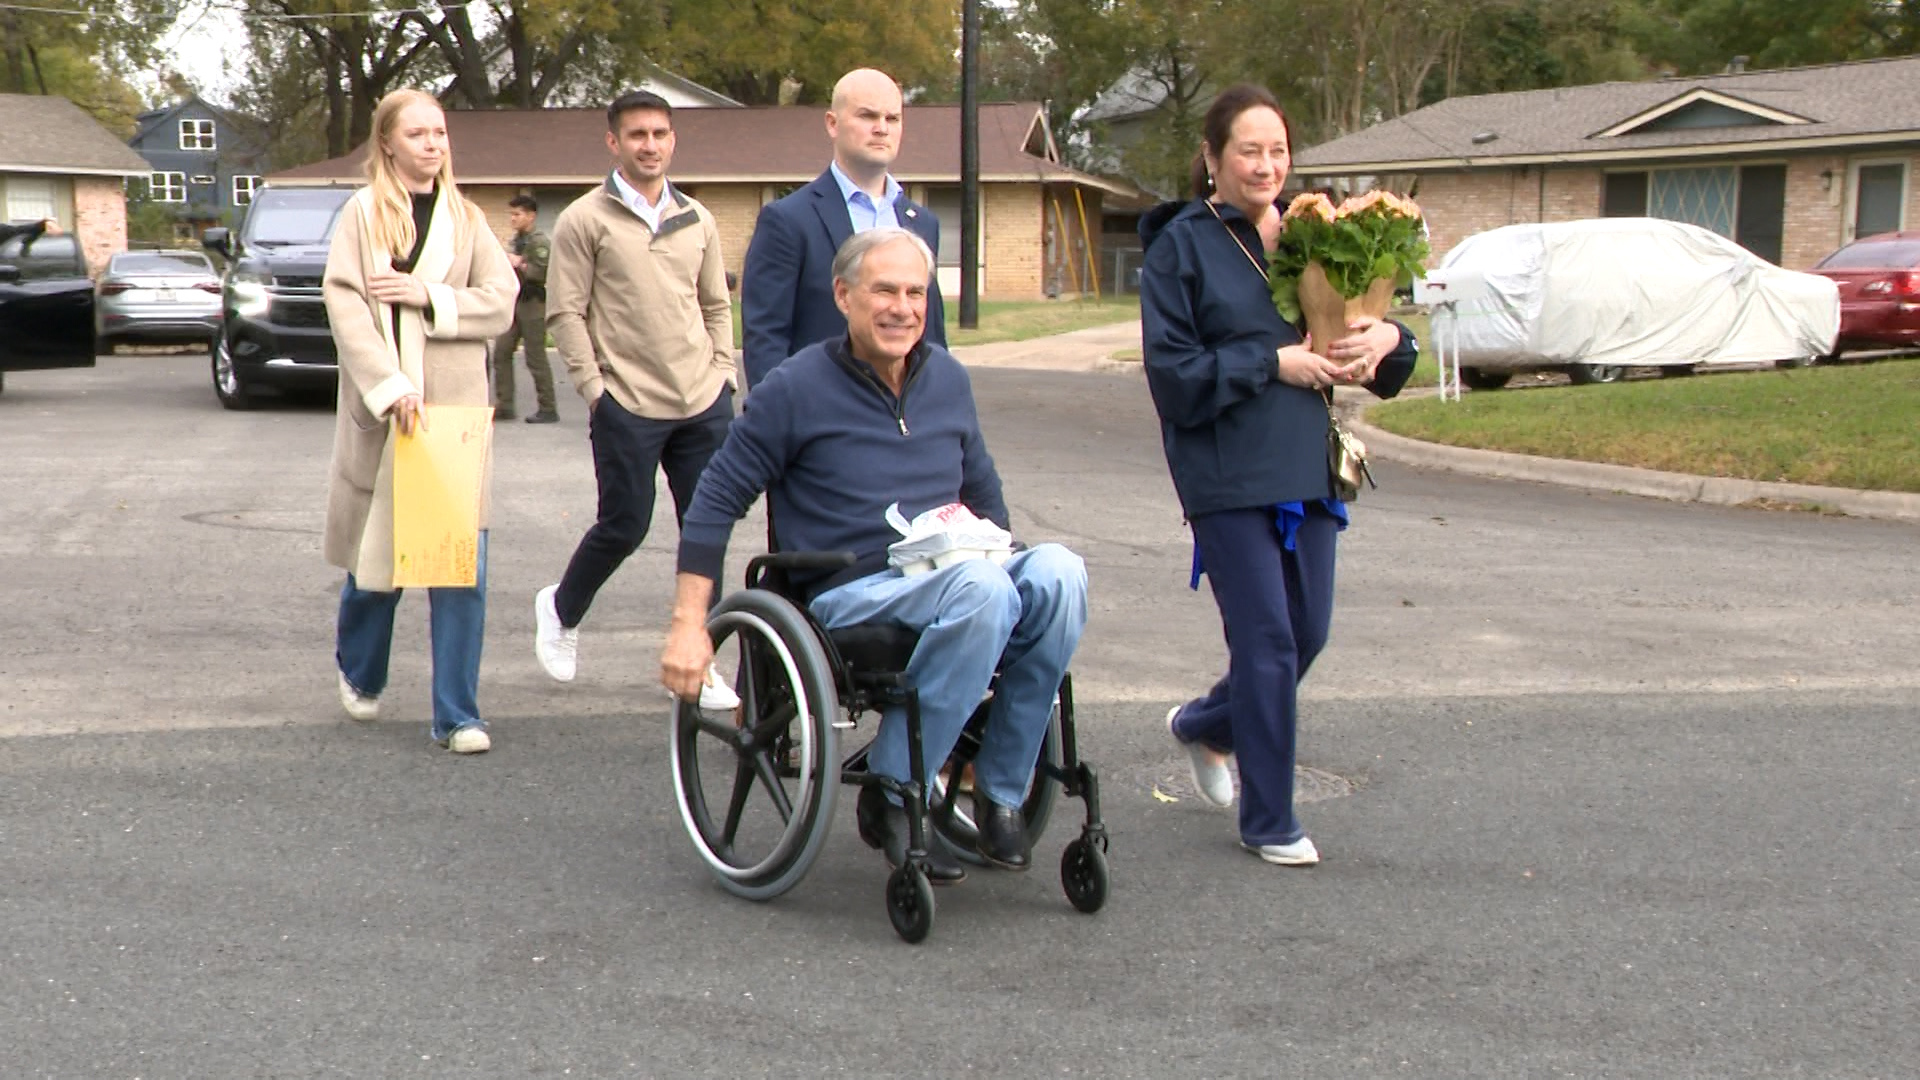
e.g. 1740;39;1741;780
1294;58;1920;269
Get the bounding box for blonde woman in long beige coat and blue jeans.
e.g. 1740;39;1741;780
324;90;520;753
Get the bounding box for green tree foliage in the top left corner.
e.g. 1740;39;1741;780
0;0;179;135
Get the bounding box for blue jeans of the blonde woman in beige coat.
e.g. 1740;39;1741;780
334;528;486;740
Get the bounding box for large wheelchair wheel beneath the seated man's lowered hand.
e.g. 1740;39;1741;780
674;588;839;899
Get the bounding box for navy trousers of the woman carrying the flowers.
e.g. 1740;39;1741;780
1175;503;1340;844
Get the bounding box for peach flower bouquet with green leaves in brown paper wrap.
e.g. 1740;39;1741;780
1267;190;1428;356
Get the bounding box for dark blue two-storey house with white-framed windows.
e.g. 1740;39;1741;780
127;94;273;227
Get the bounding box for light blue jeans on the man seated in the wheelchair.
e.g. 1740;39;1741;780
810;544;1087;807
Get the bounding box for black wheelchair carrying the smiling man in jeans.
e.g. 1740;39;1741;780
672;552;1108;944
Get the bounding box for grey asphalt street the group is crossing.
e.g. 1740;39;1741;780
0;356;1920;1078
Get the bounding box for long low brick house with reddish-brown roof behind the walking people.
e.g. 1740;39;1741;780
267;102;1131;300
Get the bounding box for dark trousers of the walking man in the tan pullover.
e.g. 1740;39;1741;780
553;388;733;626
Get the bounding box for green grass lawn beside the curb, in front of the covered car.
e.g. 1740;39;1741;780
1367;357;1920;492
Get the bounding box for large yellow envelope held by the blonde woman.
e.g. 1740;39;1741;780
394;405;493;588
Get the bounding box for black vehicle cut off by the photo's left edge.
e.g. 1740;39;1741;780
0;223;94;388
